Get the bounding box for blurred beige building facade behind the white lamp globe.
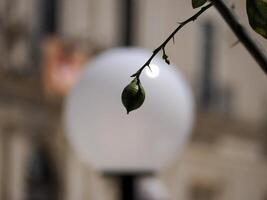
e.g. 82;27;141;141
0;0;267;200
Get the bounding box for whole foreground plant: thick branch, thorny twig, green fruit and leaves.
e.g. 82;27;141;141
122;0;267;113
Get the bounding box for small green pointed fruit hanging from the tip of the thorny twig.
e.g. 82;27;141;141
121;79;145;114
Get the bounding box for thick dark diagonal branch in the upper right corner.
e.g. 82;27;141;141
210;0;267;75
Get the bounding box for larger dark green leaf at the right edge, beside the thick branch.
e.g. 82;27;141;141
247;0;267;39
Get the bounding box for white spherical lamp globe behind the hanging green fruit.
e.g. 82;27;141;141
64;48;194;172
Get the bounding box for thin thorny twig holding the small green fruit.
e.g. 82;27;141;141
131;3;212;80
